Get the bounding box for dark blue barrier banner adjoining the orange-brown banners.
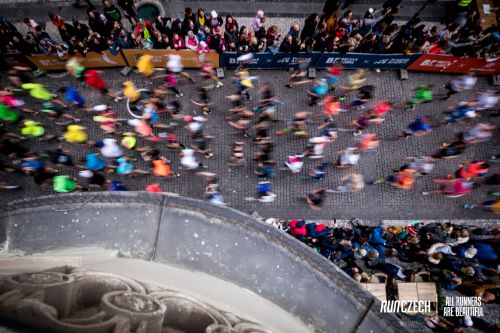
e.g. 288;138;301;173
219;52;320;69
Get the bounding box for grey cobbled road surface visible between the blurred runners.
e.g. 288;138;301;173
0;69;500;223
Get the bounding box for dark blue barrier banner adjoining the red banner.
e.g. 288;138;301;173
314;53;420;69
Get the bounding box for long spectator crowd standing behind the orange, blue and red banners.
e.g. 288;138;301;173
0;0;500;60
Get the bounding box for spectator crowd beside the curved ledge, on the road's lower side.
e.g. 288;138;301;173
266;218;500;332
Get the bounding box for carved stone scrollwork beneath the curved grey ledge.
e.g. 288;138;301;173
0;267;272;333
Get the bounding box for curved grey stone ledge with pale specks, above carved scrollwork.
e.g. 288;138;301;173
0;192;405;332
